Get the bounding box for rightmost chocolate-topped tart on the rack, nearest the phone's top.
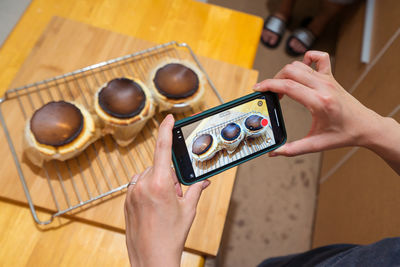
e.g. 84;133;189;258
147;58;205;112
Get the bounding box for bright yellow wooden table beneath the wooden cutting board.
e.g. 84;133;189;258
0;1;262;266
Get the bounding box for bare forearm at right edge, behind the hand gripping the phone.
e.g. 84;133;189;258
361;114;400;175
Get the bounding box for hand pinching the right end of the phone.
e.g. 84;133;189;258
254;51;383;156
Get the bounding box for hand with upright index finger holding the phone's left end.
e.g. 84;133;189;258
125;115;210;267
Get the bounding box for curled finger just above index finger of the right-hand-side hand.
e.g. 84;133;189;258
274;63;316;88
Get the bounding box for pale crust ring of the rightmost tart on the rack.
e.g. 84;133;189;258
147;58;206;112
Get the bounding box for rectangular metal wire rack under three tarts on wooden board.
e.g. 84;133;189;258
0;42;223;224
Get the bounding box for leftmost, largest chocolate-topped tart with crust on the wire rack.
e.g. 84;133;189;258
24;101;99;166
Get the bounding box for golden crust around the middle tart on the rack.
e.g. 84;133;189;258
94;76;155;146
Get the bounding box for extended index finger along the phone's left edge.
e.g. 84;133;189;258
154;114;174;173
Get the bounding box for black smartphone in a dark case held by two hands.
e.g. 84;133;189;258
172;92;286;185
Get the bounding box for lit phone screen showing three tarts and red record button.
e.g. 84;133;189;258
181;97;275;177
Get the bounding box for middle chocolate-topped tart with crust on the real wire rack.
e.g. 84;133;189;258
94;77;155;146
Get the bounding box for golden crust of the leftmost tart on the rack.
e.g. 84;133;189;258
24;102;100;167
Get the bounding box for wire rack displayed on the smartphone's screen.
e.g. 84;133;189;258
190;113;275;176
